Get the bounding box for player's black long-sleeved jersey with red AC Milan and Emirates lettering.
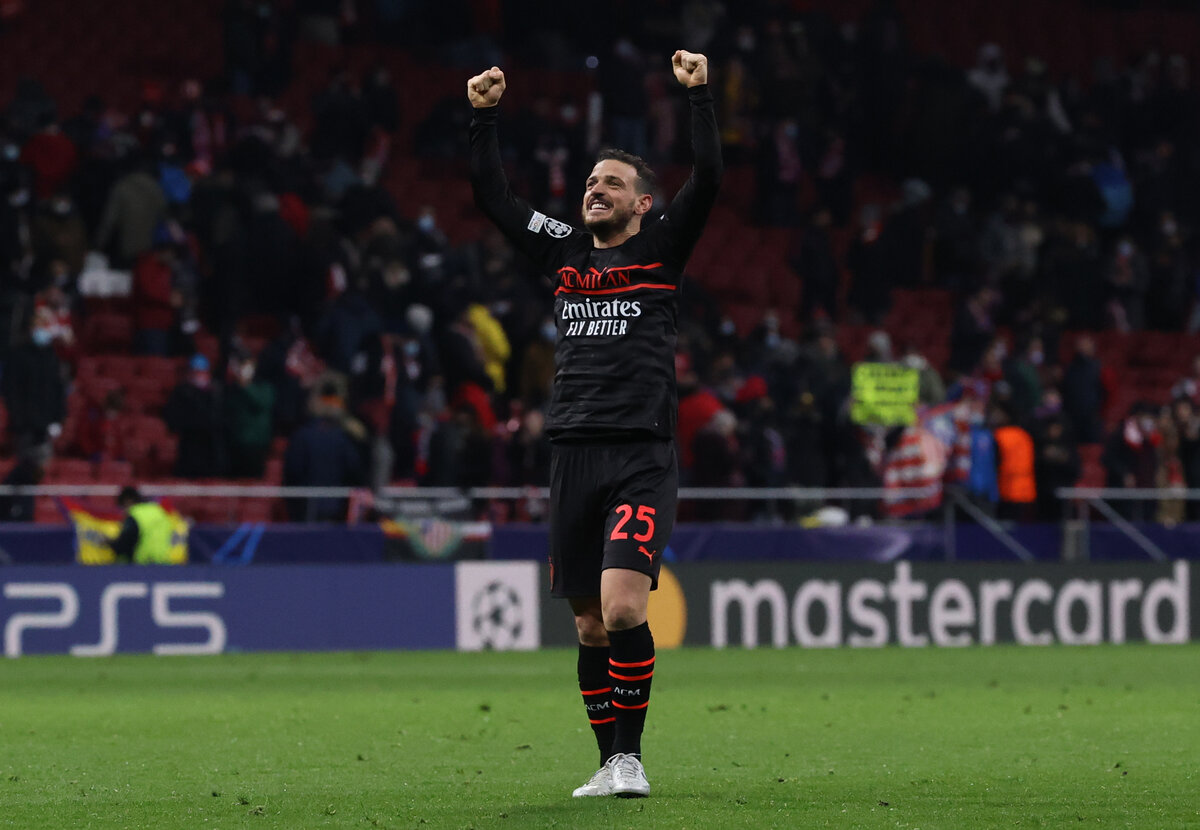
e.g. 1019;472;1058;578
470;85;721;441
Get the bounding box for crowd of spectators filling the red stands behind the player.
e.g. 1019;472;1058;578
0;0;1200;519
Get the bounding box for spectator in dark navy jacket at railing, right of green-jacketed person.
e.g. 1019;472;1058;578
283;378;366;522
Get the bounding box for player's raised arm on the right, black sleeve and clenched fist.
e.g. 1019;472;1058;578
666;49;725;259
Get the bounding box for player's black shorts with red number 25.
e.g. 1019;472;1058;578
550;441;679;597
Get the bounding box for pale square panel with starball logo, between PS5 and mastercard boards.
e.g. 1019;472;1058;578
455;563;541;651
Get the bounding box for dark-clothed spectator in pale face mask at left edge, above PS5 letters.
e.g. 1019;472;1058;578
2;306;67;451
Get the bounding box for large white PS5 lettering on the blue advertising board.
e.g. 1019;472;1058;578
4;582;227;657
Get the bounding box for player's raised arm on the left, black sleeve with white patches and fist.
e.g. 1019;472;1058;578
467;66;578;270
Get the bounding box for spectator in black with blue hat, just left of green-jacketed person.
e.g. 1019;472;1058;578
163;354;227;479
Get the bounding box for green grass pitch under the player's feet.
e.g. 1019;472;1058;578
0;645;1200;830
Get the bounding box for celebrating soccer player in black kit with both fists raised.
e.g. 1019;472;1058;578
467;50;722;796
